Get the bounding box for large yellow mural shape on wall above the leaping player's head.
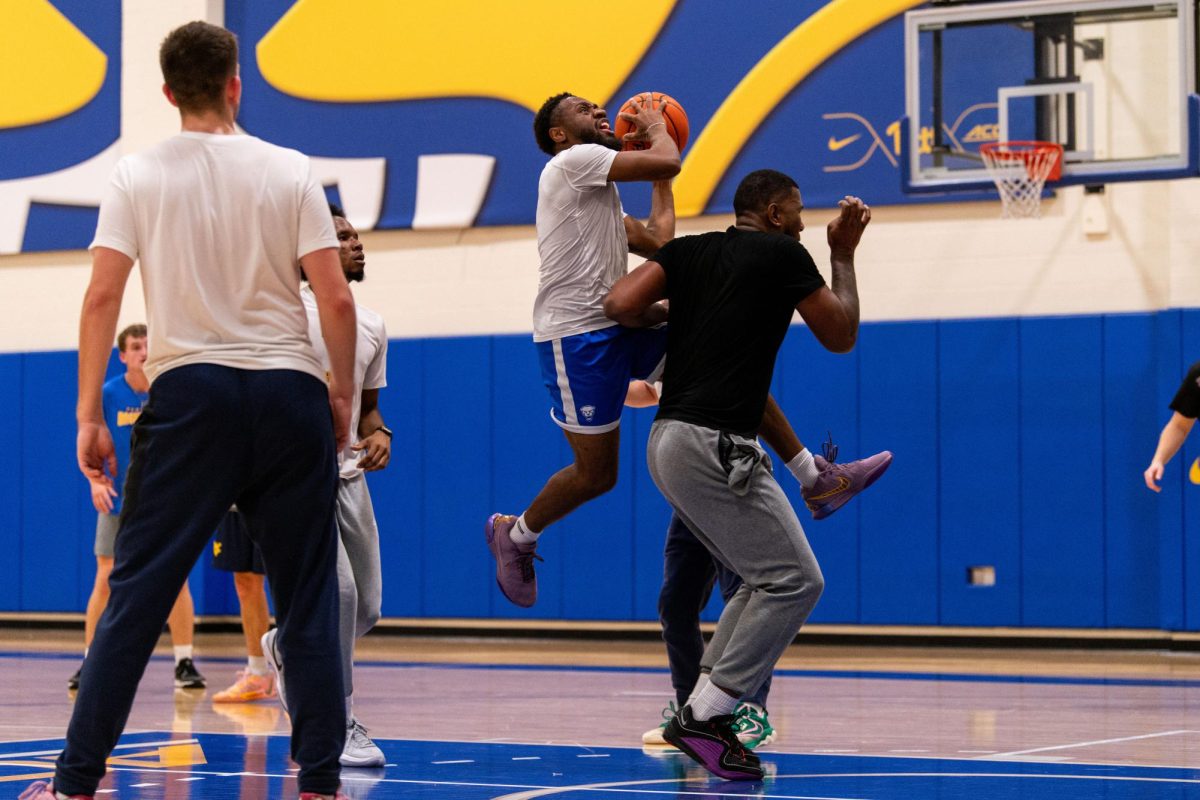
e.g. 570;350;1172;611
256;0;676;110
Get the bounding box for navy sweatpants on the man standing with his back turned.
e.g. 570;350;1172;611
54;365;346;795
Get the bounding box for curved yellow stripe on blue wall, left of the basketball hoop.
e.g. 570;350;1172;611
674;0;924;217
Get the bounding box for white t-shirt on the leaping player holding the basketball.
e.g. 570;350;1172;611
533;144;629;342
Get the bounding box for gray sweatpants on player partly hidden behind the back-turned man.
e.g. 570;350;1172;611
336;474;383;697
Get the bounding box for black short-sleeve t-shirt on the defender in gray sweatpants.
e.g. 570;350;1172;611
652;228;824;435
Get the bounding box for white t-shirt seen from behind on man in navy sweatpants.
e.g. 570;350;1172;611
91;132;337;380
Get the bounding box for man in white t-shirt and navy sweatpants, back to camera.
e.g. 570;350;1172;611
22;22;355;800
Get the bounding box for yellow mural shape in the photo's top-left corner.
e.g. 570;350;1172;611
0;0;108;128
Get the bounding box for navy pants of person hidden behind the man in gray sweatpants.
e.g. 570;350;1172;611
659;515;770;708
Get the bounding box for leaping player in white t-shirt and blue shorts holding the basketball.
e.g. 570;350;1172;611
485;92;679;607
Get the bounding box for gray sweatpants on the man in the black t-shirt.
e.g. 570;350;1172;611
647;420;824;696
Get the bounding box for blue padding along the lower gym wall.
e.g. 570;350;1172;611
9;309;1200;630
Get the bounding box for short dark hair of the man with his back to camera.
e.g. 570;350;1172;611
158;22;238;113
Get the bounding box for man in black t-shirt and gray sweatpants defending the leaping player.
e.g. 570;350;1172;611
605;170;873;780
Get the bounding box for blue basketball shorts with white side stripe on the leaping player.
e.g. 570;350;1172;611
536;325;667;433
